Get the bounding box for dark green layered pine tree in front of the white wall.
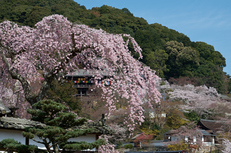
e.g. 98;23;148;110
23;100;104;153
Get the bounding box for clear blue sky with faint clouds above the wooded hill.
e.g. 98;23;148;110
75;0;231;75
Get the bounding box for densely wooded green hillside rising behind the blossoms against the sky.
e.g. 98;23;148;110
0;0;230;93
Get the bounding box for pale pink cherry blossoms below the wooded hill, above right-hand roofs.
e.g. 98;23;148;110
162;84;222;114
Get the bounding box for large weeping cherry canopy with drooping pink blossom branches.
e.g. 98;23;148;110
0;15;160;131
